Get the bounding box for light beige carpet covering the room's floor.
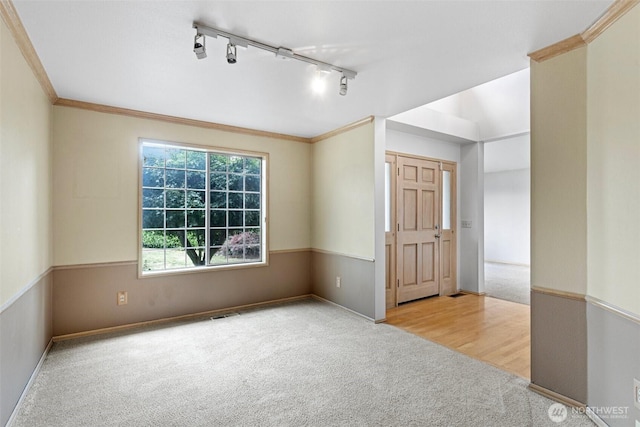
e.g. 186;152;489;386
14;300;592;427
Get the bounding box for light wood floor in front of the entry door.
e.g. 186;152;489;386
386;294;531;379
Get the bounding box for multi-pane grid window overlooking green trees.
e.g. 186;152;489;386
140;141;266;274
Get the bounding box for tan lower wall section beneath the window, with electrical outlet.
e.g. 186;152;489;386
53;251;311;336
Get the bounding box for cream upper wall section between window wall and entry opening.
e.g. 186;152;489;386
312;123;375;259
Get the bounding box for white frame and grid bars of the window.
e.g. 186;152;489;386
138;138;269;277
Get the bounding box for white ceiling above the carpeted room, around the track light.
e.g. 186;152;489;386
13;0;612;137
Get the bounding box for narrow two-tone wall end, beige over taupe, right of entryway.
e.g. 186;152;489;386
531;46;587;403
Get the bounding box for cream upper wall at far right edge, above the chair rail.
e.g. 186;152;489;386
587;7;640;315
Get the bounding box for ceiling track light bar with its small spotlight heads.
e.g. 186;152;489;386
193;22;358;96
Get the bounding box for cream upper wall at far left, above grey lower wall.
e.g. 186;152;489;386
0;20;52;306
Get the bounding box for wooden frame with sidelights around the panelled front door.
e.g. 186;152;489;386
385;151;459;309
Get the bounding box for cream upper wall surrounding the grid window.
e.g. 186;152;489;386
53;107;311;265
